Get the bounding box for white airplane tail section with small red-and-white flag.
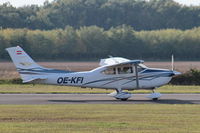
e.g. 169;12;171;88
6;46;46;83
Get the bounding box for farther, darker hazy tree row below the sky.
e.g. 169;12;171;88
0;0;200;31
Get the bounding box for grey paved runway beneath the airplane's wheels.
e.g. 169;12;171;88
0;94;200;104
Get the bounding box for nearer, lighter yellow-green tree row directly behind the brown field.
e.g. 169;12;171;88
0;25;200;60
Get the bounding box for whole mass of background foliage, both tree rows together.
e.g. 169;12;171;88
0;0;200;60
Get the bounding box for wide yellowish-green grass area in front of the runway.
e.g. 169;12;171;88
0;104;200;133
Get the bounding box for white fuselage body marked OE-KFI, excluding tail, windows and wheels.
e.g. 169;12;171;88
35;67;173;89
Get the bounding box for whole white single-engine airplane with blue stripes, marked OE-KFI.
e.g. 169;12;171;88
6;46;180;101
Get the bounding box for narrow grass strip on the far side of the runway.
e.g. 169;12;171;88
0;84;200;93
